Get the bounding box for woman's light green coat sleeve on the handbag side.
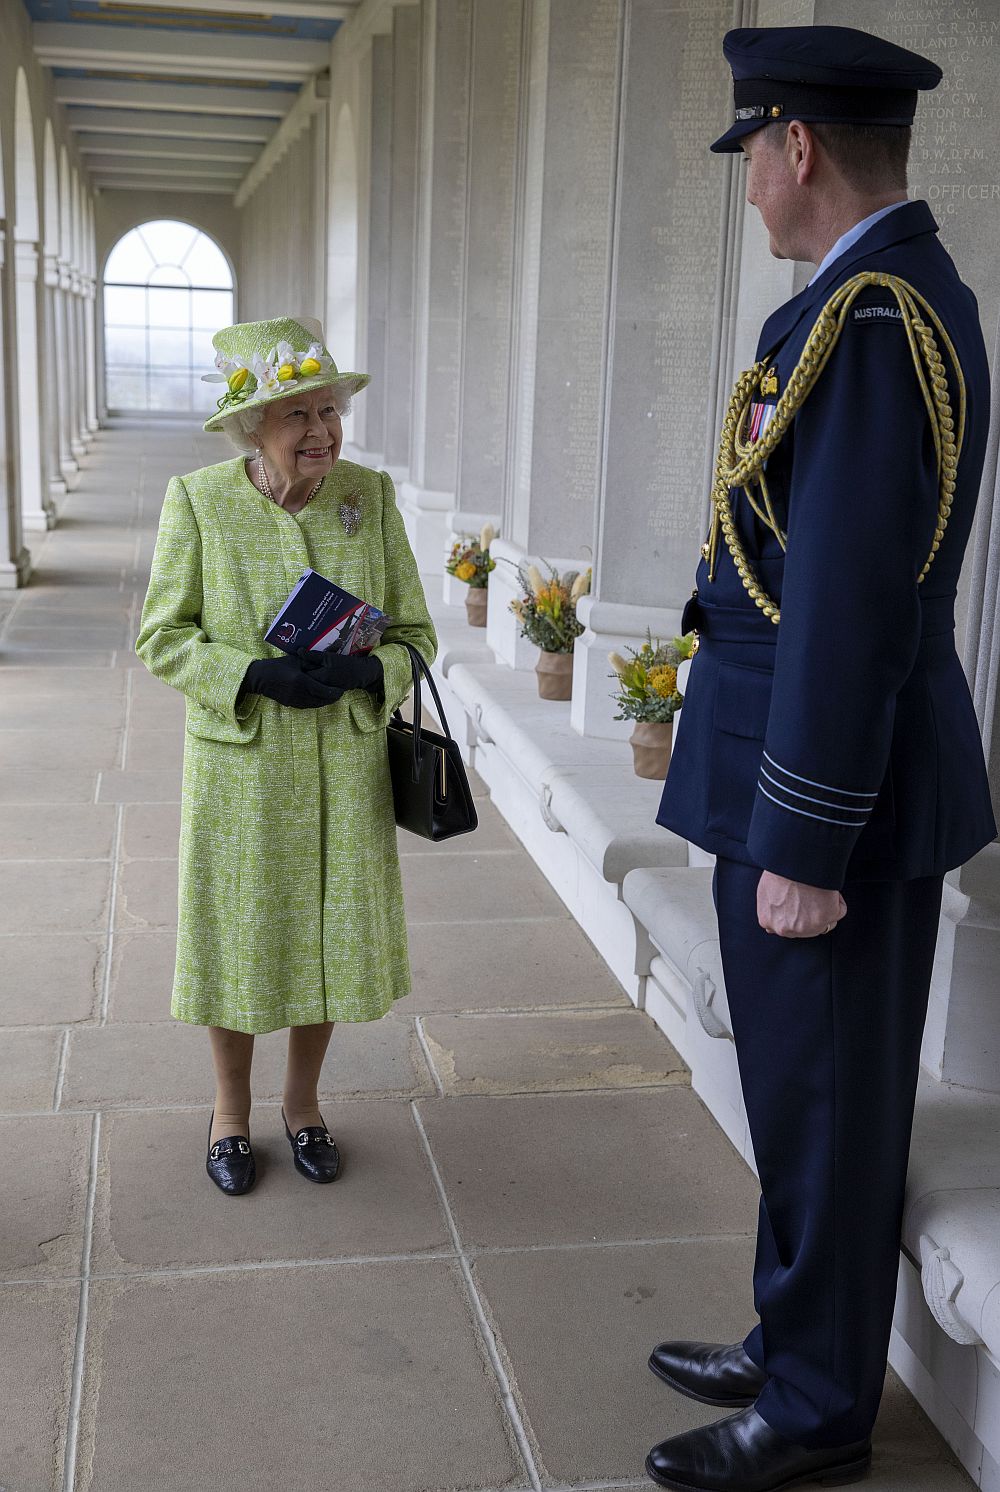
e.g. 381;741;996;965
348;471;437;731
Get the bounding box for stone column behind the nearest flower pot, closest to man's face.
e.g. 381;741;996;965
572;0;731;737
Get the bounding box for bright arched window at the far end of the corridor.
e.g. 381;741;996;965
104;219;233;416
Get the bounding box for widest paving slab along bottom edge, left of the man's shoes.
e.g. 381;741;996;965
78;1259;524;1492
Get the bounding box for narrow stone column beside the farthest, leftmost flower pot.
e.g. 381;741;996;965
400;0;472;573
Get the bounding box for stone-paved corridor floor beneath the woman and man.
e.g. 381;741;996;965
0;425;970;1492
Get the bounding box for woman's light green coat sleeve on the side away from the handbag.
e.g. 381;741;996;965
136;476;260;742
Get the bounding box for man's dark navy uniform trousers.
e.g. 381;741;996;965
715;859;942;1449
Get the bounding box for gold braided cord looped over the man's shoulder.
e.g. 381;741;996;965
703;270;966;625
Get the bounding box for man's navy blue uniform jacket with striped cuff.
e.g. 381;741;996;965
657;201;997;889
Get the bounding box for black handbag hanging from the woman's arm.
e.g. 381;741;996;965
385;643;479;840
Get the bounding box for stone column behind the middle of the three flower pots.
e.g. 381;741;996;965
487;0;622;667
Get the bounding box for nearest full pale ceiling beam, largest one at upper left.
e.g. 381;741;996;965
31;21;330;82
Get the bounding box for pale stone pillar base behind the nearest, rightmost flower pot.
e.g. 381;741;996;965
570;595;681;740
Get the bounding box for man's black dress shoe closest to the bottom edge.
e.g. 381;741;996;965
646;1408;872;1492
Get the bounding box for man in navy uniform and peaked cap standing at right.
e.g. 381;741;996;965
646;25;997;1492
